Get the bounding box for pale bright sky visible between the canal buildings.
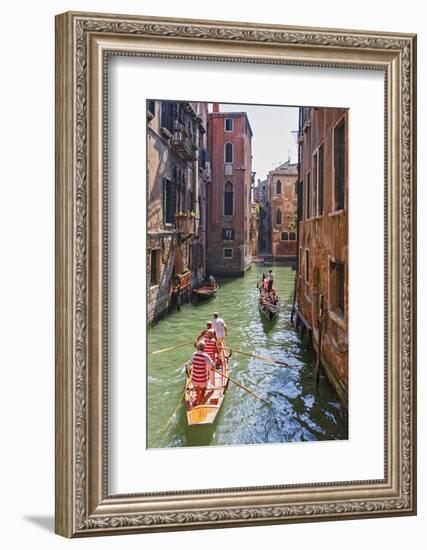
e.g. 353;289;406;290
209;103;298;181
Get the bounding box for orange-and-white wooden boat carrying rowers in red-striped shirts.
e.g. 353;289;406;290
185;350;228;426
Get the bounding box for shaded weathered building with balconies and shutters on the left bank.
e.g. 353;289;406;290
147;100;210;321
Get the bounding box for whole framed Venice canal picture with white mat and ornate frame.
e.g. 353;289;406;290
56;12;416;537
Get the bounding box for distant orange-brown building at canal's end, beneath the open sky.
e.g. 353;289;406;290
267;160;298;260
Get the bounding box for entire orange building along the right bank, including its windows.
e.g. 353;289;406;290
297;108;348;404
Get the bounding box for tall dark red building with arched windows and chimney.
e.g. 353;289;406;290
206;103;253;275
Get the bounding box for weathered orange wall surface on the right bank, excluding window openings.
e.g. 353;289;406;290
298;109;349;406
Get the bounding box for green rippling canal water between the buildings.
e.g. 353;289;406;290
147;266;348;448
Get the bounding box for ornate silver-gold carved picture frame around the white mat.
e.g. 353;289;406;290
55;13;416;537
